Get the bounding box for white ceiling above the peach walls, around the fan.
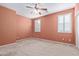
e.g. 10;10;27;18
0;3;75;18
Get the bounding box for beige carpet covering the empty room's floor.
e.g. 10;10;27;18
0;38;79;56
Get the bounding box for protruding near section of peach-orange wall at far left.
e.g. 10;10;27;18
0;6;16;45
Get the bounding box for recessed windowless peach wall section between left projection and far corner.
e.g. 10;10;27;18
16;15;32;39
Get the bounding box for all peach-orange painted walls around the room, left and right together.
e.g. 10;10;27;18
0;6;75;45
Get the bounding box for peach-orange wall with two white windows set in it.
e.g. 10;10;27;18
33;8;75;44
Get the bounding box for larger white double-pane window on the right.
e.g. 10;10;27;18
58;13;72;33
